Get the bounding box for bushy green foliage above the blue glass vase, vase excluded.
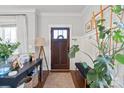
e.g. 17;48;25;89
0;38;20;63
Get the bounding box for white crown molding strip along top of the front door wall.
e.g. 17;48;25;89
40;13;81;16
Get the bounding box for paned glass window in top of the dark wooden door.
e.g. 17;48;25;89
53;29;67;39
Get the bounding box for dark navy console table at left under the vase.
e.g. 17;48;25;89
0;59;42;88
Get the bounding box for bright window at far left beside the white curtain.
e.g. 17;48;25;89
0;25;17;43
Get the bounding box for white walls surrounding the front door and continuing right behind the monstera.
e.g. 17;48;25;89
37;6;105;70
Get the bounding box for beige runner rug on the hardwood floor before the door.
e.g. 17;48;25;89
44;72;75;88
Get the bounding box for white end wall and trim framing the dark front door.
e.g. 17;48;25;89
37;14;83;68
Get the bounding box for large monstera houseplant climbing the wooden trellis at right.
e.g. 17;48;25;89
69;5;124;88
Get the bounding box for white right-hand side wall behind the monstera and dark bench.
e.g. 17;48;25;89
71;5;99;69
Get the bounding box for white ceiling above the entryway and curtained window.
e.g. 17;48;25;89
0;5;85;13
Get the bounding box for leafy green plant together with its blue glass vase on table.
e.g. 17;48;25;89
0;38;20;75
